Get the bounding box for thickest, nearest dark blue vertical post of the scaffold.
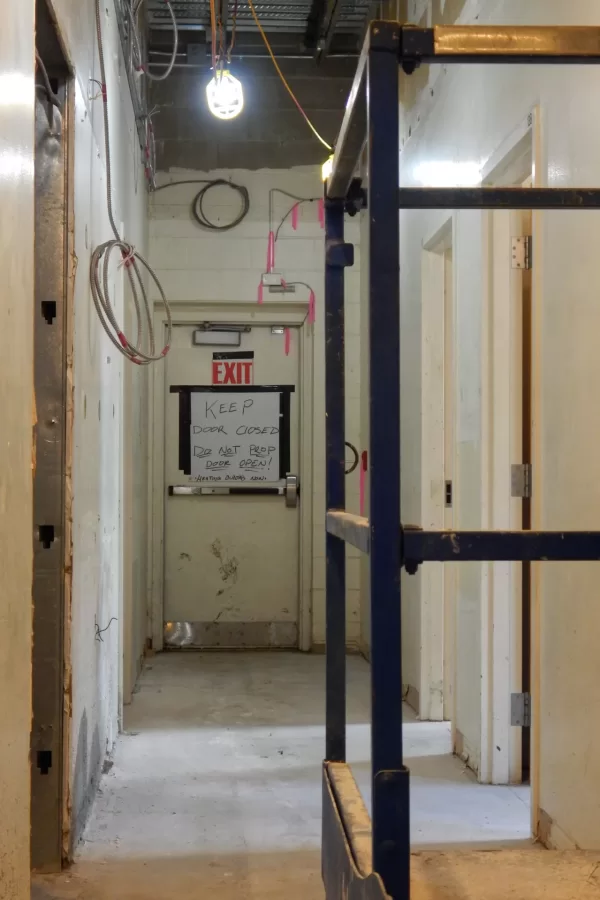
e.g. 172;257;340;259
367;22;410;900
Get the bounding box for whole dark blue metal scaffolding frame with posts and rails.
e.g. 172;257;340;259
322;21;600;900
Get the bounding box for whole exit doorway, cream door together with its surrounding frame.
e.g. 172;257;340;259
152;302;312;650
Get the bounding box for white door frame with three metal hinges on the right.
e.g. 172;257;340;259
479;106;543;788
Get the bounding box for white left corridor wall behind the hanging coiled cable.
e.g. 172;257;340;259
53;0;147;841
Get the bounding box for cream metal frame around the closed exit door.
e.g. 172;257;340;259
148;300;313;651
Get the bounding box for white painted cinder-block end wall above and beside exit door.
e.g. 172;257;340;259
150;167;360;644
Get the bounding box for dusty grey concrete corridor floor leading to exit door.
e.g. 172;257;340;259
32;653;600;900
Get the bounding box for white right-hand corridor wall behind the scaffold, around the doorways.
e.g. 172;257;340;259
394;0;600;849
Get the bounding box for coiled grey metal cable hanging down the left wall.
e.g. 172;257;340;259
90;0;172;366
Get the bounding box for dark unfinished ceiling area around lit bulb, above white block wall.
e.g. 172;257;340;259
146;0;373;172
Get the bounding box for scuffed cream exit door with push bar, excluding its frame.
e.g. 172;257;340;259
164;325;301;648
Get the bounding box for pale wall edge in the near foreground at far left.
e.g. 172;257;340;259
0;3;35;900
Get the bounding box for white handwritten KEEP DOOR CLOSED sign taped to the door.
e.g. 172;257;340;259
190;391;281;483
